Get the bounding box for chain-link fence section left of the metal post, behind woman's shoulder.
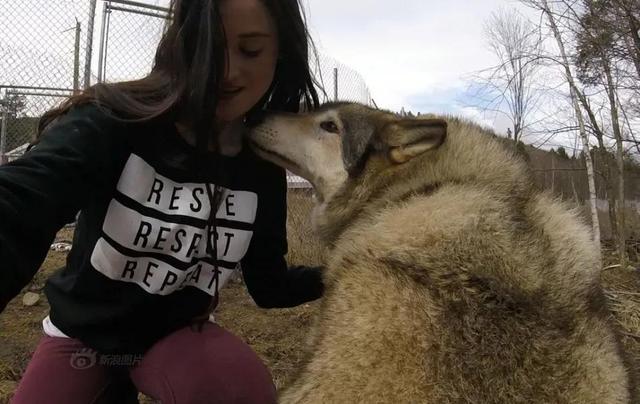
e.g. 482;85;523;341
0;0;90;164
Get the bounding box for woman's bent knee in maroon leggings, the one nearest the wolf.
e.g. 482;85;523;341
132;324;276;403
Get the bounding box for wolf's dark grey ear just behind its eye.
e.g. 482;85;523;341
342;117;375;175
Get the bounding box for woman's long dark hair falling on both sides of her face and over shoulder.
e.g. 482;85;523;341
38;0;319;145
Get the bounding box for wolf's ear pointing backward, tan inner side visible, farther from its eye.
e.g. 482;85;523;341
381;119;447;164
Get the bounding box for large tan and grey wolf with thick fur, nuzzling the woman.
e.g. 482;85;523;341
248;103;637;404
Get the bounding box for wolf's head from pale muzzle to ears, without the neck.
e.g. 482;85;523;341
250;103;447;201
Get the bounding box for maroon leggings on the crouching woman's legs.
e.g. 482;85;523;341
11;323;276;404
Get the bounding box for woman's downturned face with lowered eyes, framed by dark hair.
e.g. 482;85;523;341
216;0;278;122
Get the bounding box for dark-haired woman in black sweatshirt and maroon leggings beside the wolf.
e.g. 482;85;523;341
0;0;323;404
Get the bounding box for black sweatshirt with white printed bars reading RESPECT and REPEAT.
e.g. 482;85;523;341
0;105;322;354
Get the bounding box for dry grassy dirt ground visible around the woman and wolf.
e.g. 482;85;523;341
0;215;640;404
